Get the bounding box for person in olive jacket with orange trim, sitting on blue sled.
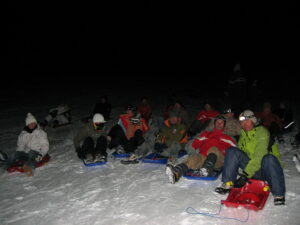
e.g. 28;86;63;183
154;111;188;164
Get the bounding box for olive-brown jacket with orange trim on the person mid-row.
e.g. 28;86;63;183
157;120;188;147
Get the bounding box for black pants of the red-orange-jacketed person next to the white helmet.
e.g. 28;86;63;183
108;125;145;153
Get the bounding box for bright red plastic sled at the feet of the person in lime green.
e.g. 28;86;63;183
221;179;270;211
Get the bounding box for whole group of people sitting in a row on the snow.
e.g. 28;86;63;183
0;95;292;205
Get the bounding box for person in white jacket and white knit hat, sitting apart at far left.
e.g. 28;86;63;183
1;113;49;176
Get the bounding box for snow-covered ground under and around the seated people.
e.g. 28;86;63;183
0;85;300;225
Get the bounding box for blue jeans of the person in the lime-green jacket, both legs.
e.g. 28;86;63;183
222;147;285;196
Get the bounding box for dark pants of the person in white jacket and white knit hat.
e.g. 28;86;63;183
6;150;40;169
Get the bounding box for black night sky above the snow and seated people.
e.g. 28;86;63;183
6;1;300;93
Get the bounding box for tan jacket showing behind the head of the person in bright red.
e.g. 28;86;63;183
205;117;242;137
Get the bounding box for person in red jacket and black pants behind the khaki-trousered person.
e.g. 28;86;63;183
188;102;220;137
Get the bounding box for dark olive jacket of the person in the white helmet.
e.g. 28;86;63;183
73;122;108;148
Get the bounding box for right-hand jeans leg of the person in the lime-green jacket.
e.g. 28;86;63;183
261;154;285;196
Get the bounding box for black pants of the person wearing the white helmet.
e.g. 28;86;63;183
77;136;107;159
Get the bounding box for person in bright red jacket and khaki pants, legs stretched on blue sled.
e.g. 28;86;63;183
166;115;236;184
